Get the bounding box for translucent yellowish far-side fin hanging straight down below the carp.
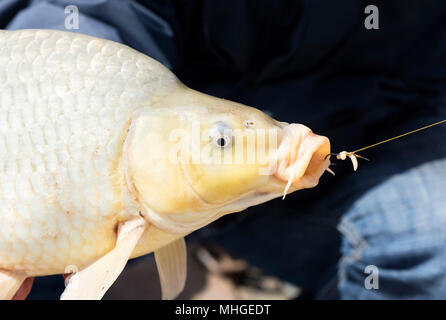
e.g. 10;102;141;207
155;238;187;300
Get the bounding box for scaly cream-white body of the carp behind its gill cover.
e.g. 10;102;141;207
0;30;181;276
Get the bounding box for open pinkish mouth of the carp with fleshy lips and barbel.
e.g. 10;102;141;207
274;124;330;197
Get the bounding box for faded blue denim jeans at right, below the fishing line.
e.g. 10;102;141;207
337;159;446;299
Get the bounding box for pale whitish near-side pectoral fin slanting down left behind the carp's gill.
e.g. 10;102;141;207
61;218;147;300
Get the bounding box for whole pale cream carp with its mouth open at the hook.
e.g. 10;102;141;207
0;30;330;298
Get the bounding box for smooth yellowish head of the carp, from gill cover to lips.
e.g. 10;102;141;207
125;87;330;232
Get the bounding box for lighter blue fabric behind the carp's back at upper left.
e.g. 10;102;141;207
0;0;176;67
